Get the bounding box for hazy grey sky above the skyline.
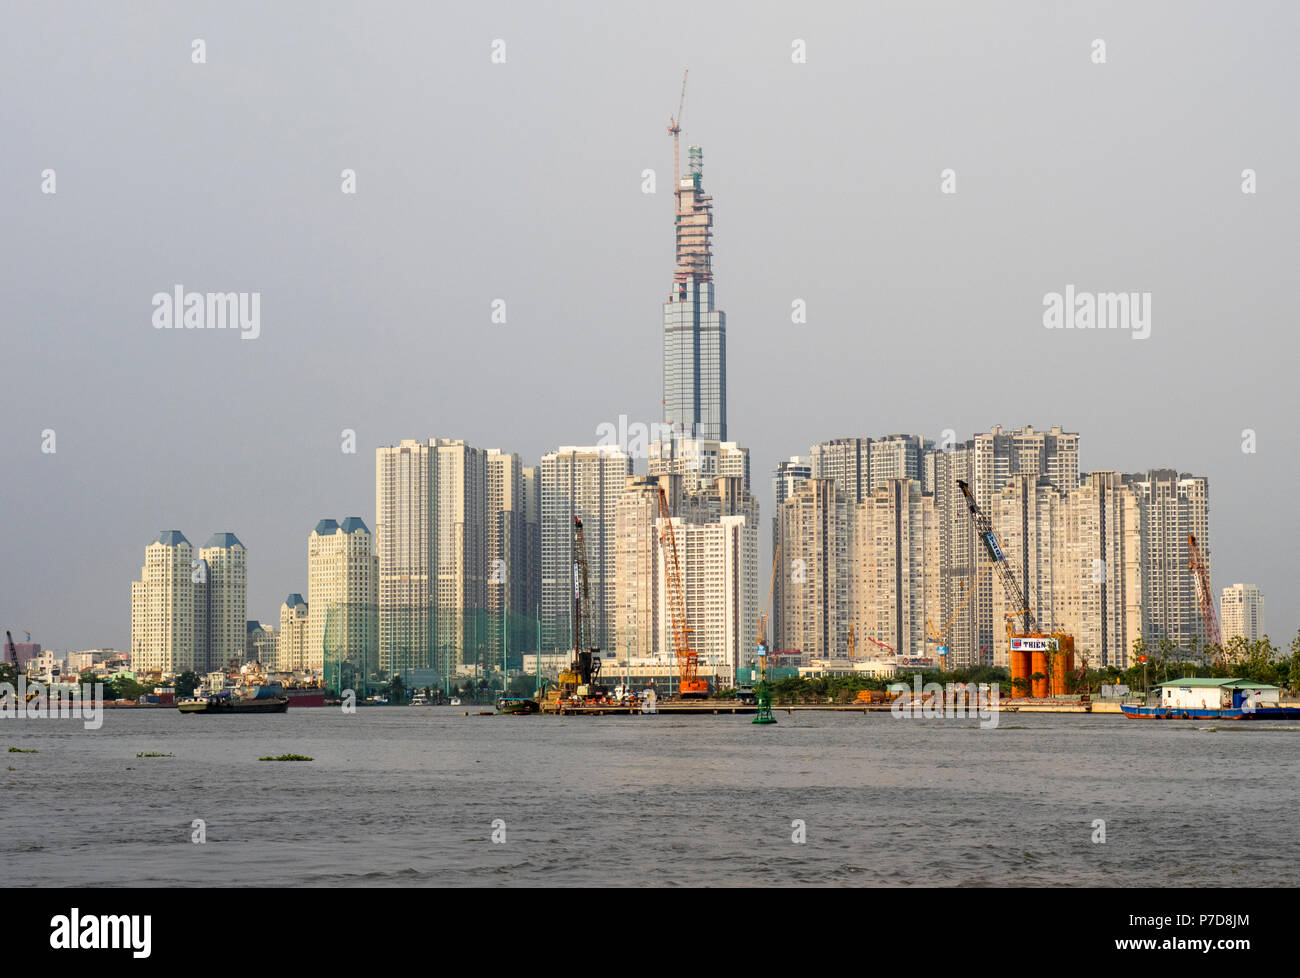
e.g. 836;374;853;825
0;0;1300;650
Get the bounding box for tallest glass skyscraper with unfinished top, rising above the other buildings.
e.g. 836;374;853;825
663;139;727;441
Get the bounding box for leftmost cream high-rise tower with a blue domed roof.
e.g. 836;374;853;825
131;529;199;674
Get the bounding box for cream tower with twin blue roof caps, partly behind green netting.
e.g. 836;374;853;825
303;516;380;689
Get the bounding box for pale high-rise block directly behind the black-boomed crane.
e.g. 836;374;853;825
541;445;632;653
